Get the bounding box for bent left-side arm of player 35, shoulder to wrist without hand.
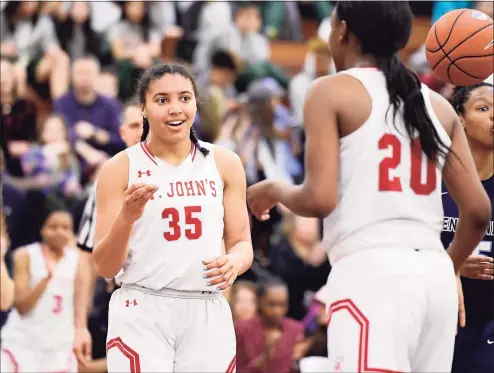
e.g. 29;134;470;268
93;152;133;278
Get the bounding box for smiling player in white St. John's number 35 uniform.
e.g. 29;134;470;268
93;64;253;373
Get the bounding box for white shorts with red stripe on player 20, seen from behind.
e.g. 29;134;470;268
326;249;458;373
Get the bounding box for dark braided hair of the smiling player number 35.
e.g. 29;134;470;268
137;63;209;156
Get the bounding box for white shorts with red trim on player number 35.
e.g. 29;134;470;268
106;285;236;373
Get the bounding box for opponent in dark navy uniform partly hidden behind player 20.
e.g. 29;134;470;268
441;83;494;373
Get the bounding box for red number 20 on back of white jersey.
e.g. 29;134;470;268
378;133;437;195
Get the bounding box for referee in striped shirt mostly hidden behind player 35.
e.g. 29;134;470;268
74;98;143;368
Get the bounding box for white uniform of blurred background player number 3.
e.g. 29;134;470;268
1;243;79;373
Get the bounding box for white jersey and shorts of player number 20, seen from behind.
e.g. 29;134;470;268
324;68;458;372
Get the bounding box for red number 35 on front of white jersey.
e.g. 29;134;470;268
161;206;202;241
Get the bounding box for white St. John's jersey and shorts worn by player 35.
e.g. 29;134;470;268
107;142;236;373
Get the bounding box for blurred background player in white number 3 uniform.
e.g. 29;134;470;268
2;211;79;373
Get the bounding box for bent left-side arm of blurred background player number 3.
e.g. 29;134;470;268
13;249;52;315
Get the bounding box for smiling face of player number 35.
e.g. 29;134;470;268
141;74;197;144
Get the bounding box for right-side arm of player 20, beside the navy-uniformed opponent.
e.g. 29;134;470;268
431;92;491;271
